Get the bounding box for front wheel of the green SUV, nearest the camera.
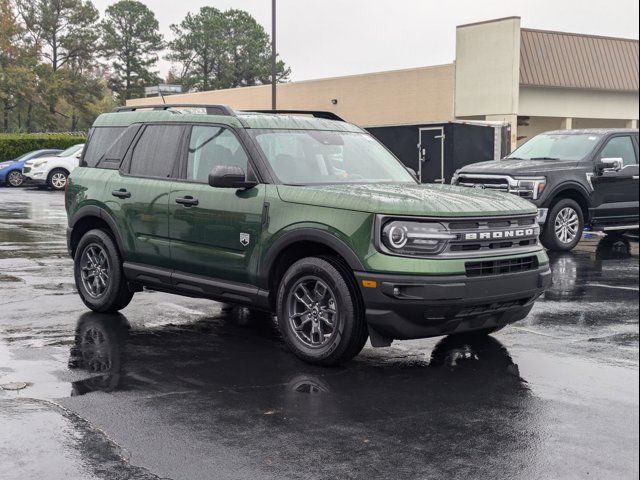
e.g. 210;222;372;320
277;257;368;365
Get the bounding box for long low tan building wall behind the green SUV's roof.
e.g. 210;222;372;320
127;64;455;127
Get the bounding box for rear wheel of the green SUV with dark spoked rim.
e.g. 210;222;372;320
74;230;133;312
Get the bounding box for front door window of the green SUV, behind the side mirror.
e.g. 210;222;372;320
187;125;248;183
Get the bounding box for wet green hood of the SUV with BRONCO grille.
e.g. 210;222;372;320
278;184;537;217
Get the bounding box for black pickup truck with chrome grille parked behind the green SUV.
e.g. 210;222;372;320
451;129;638;250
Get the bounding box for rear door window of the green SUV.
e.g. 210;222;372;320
129;125;183;178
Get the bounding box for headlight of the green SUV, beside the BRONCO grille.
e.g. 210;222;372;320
380;220;458;256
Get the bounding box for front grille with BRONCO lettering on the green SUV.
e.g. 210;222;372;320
445;215;540;256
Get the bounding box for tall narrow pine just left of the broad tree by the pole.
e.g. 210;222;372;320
101;0;164;100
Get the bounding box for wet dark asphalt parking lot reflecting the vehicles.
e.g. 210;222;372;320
0;188;639;480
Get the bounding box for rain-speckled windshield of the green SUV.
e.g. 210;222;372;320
249;129;416;185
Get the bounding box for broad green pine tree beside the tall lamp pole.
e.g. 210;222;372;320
167;7;290;91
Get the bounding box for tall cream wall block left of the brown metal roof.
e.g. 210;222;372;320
455;17;520;117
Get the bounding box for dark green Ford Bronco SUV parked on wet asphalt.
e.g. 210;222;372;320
66;105;551;365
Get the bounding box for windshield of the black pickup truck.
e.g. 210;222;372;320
507;133;602;160
